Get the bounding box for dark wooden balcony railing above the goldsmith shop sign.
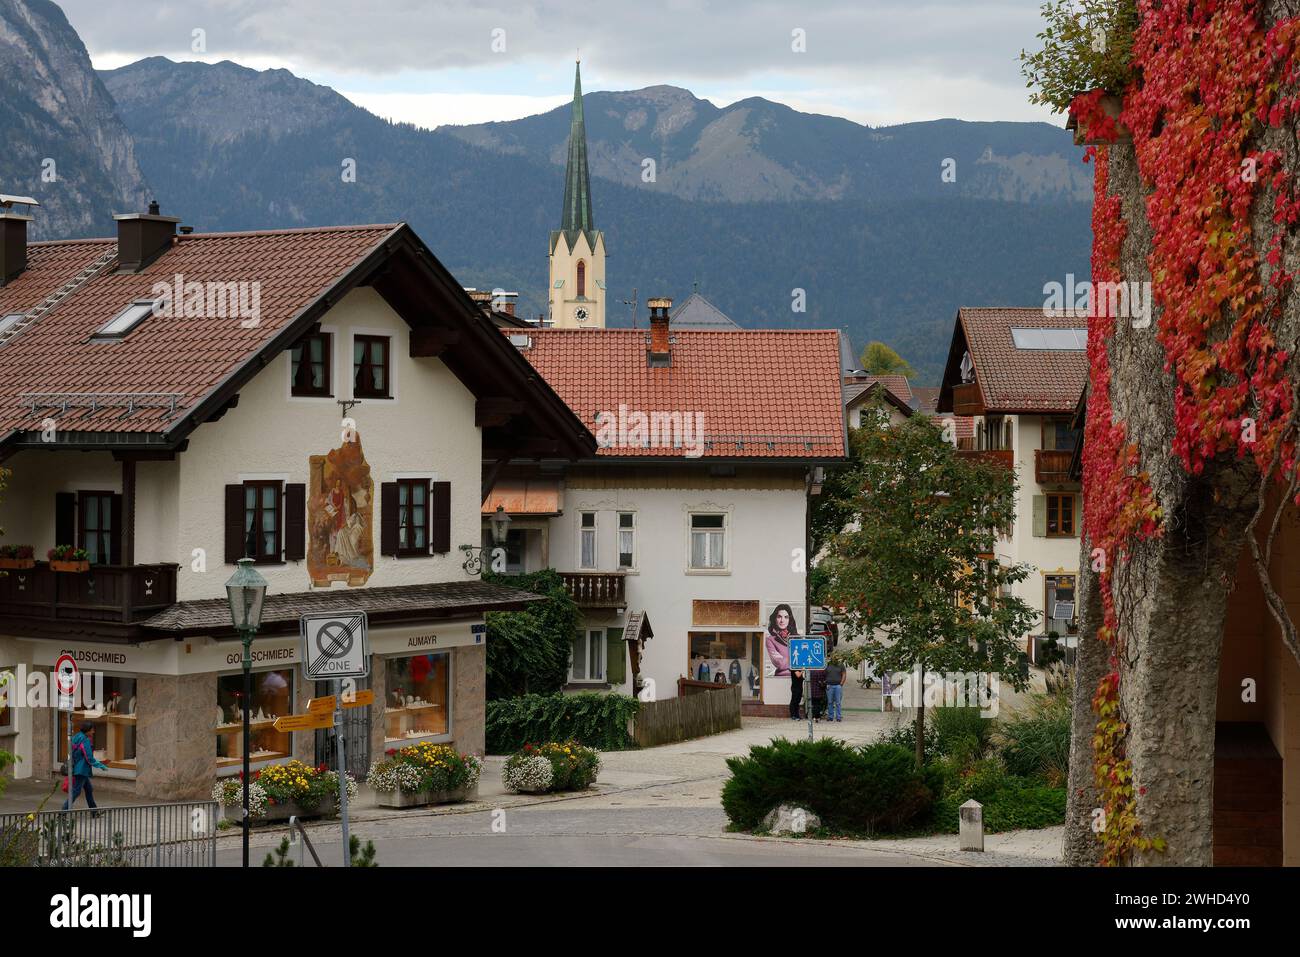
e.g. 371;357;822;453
0;562;179;625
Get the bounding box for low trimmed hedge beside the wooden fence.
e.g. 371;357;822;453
486;692;638;754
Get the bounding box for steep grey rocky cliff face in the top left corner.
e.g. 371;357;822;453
0;0;150;239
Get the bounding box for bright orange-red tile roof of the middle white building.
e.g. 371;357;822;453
503;329;844;459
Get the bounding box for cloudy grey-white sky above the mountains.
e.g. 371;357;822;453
59;0;1063;126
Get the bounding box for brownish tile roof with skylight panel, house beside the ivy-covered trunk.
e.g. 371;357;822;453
944;307;1088;413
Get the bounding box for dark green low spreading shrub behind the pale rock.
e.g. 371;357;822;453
723;739;939;833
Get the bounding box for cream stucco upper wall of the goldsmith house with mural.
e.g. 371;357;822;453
0;289;482;601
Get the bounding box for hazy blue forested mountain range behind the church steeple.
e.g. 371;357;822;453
0;0;1091;382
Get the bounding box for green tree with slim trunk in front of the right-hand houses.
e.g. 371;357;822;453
822;416;1036;765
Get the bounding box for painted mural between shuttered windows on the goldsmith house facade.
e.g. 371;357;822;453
307;432;374;586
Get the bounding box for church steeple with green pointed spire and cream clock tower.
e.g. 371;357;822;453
547;64;605;329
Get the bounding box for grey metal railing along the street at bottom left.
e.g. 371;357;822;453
0;801;220;867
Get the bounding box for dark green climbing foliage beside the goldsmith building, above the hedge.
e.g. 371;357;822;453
482;568;582;698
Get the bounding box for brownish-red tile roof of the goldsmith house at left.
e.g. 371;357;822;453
0;225;399;437
